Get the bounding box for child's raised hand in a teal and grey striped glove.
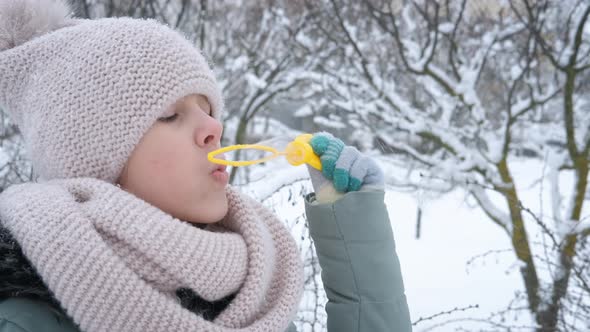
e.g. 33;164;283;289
308;132;384;203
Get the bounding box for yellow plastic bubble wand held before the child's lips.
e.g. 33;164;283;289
207;134;322;171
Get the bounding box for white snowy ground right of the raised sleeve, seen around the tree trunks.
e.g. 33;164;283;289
386;161;588;331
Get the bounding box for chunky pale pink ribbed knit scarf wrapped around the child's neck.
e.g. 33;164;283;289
0;178;303;332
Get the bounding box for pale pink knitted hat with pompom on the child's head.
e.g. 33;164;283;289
0;0;223;183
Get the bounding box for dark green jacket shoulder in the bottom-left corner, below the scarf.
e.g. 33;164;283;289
0;297;79;332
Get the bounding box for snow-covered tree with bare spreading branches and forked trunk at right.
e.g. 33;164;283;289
308;0;590;331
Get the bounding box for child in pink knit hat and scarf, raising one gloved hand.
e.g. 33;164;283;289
0;0;411;332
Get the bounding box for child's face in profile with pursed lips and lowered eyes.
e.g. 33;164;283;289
118;95;228;223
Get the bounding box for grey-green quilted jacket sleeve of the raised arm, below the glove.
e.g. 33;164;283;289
305;191;412;332
